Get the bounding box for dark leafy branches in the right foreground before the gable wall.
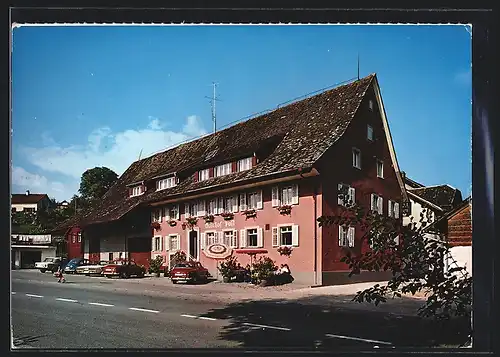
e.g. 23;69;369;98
318;195;472;319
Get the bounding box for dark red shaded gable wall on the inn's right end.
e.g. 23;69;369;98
320;85;401;272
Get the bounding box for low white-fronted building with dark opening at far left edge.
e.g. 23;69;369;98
11;234;56;269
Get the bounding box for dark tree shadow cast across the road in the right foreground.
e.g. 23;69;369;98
198;296;470;349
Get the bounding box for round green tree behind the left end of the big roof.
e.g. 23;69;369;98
79;167;118;208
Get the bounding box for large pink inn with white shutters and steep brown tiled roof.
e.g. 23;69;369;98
55;75;406;285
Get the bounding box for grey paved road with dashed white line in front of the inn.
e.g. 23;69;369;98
11;272;468;350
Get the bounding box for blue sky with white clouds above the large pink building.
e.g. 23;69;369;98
12;25;472;201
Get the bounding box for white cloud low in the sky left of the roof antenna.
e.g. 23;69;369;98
12;115;206;199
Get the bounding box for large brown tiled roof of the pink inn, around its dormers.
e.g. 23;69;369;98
61;74;375;228
